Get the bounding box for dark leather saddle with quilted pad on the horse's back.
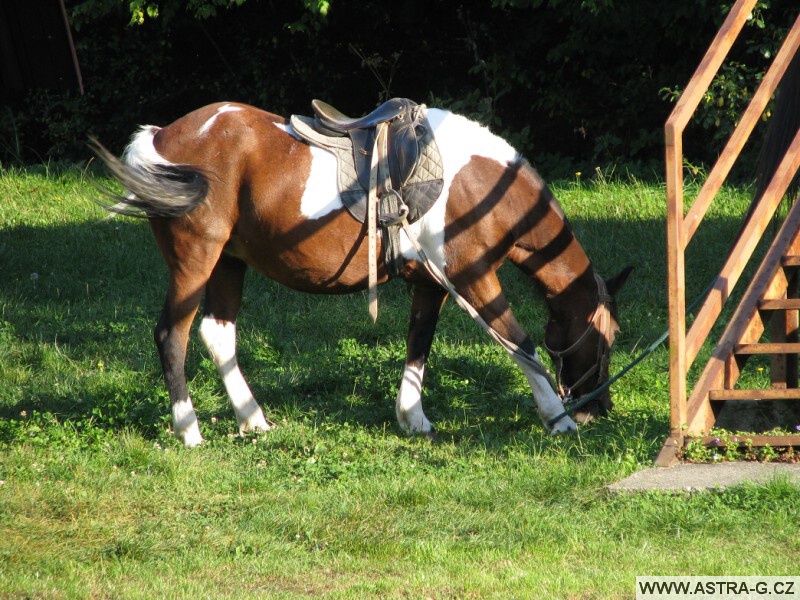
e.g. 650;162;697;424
290;98;444;264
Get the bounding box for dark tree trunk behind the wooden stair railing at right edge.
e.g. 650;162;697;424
748;53;800;217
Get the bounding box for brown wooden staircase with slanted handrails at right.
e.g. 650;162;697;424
656;0;800;466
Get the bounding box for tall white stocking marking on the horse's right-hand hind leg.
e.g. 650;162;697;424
200;316;271;433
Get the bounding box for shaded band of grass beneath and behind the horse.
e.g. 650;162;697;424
0;211;752;460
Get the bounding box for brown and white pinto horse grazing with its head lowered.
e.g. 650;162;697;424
95;102;630;447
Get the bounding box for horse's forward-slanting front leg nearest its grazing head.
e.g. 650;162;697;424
453;271;578;435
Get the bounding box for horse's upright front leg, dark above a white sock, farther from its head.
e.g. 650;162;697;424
395;285;447;438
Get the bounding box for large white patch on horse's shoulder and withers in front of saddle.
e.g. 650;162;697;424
400;108;520;270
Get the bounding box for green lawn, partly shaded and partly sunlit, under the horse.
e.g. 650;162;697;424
0;163;800;598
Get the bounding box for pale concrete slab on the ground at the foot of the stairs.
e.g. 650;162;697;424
608;462;800;493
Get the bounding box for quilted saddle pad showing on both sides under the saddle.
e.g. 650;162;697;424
290;109;444;223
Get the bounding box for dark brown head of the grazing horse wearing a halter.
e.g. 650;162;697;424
545;267;633;423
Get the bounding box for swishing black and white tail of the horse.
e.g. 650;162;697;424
90;126;208;217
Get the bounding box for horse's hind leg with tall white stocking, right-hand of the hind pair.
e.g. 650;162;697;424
200;254;271;433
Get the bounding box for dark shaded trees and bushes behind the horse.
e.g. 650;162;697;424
0;0;797;178
